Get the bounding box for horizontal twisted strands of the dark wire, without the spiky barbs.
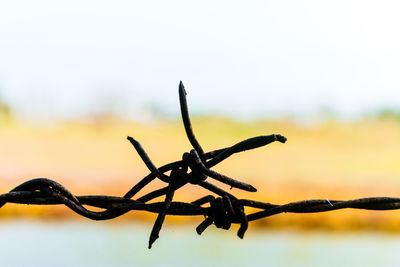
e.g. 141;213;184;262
0;181;400;229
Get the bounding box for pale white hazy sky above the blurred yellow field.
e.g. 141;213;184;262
0;0;400;117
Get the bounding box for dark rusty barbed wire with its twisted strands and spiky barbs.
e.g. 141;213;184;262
0;82;400;248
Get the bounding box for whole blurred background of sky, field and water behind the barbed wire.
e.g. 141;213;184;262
0;0;400;266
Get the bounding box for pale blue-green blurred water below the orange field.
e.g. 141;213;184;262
0;221;400;267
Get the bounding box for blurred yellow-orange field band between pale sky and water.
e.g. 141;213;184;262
0;117;400;231
